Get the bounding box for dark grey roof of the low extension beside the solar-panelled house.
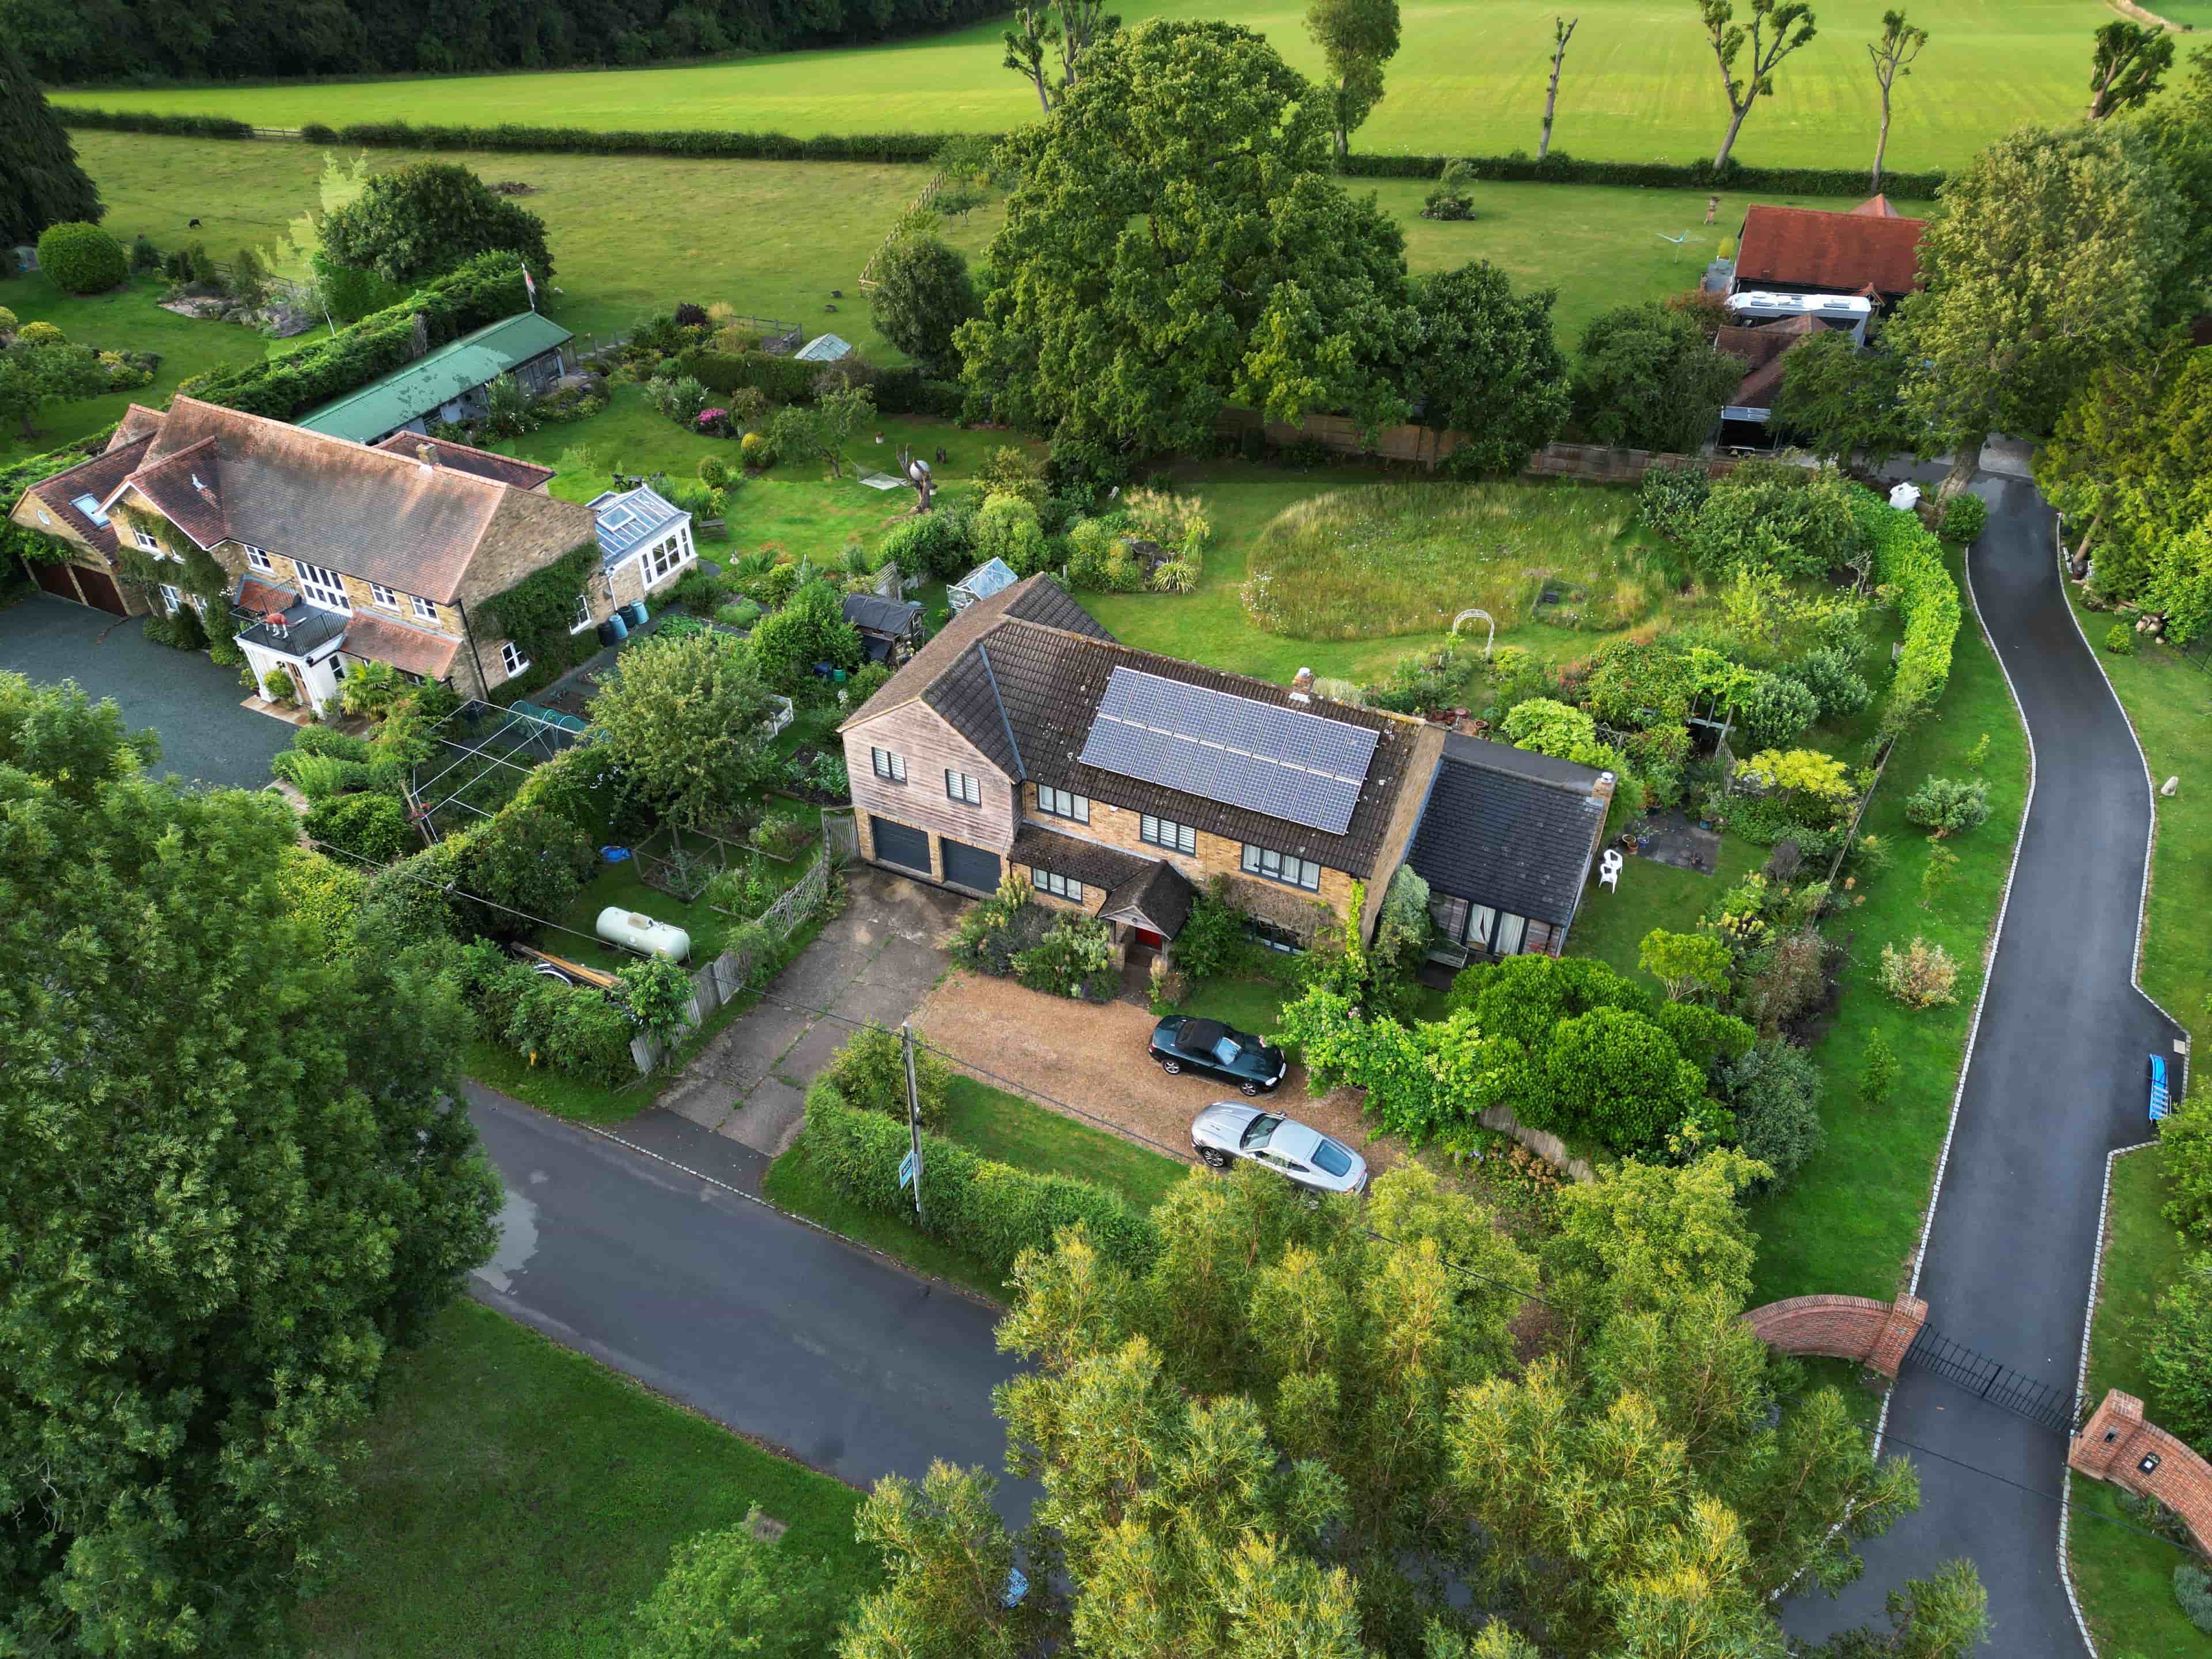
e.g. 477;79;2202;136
1409;732;1606;925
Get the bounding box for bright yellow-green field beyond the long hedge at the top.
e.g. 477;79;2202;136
56;0;2105;168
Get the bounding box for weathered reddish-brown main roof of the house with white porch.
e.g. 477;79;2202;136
96;396;593;604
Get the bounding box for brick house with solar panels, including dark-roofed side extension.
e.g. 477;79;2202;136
840;577;1612;960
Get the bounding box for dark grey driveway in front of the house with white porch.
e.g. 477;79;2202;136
0;593;292;790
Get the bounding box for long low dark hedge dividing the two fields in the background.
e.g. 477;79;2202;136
53;104;1944;197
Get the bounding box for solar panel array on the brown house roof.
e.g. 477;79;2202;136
1082;668;1376;836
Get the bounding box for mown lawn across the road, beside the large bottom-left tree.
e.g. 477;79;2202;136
292;1301;878;1659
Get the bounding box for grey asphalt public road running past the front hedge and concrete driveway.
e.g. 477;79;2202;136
467;1084;1035;1522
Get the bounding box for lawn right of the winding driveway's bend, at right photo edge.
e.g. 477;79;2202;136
2066;582;2212;1086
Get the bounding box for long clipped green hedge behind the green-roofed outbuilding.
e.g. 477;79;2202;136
177;252;529;421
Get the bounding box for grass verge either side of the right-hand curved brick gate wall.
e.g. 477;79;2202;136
2068;1150;2212;1659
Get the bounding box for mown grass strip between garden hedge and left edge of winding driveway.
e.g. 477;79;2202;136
1749;555;2028;1303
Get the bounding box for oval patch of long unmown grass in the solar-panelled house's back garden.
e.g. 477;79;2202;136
1250;482;1668;639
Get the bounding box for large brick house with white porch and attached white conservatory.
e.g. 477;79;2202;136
11;407;695;708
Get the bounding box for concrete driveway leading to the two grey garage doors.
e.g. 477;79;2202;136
646;865;967;1192
